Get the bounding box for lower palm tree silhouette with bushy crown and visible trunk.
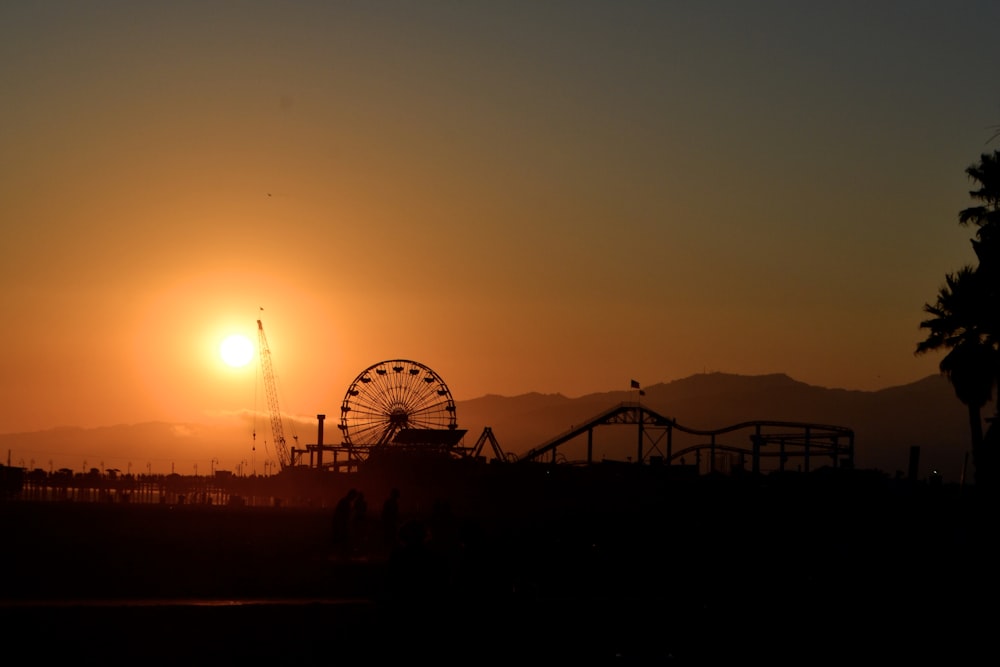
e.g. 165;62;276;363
916;266;1000;486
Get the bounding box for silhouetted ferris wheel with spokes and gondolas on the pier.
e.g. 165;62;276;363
338;359;457;446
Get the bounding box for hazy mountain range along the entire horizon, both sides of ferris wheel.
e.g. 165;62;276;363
0;373;990;482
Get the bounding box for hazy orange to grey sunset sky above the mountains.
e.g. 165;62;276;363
0;0;1000;433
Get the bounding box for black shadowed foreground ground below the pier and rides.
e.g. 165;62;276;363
0;477;998;665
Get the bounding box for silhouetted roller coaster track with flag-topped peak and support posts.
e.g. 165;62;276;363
518;403;854;473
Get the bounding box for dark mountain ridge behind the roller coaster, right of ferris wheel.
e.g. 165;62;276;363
457;373;971;482
